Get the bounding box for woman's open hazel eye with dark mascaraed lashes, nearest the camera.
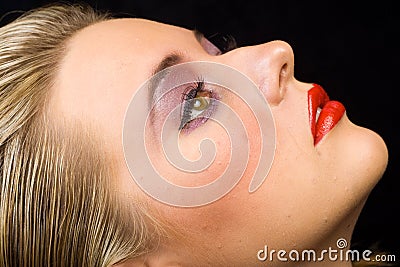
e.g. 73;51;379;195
179;82;215;130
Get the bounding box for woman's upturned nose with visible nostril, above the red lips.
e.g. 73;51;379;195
226;41;294;105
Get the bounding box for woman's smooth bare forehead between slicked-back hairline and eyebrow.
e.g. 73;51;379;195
52;19;201;140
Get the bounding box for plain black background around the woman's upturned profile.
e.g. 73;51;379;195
0;0;400;262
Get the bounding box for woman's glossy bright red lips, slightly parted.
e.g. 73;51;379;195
308;83;345;146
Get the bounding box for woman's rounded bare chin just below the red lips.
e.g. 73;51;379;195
317;114;388;200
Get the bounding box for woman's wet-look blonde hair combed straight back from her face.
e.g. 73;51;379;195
0;4;156;267
